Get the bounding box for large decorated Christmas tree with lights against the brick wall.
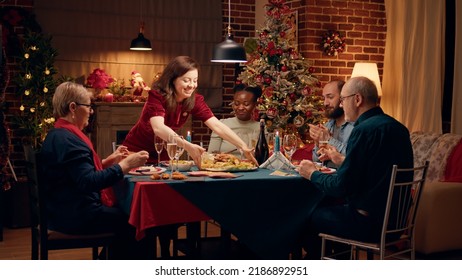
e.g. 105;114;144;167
237;0;324;138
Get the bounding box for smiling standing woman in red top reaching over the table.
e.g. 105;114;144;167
123;56;257;166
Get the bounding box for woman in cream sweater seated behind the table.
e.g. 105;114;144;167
208;84;262;156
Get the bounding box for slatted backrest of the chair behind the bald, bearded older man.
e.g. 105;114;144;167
381;161;429;244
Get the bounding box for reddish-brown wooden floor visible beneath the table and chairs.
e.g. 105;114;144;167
0;225;462;260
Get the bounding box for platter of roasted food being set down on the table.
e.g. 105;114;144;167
201;153;256;171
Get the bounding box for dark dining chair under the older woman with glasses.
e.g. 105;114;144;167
25;147;115;260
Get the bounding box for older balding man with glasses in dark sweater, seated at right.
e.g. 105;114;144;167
298;77;413;259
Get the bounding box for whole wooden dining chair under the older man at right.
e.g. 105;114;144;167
319;161;429;260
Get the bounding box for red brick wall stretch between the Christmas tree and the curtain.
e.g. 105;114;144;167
292;0;386;85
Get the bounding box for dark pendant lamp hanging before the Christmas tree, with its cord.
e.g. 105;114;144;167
211;0;247;63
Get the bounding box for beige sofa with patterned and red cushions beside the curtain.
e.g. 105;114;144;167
411;132;462;255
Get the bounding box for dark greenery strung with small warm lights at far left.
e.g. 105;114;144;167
14;32;57;148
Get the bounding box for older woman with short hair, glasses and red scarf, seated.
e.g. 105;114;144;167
37;82;148;259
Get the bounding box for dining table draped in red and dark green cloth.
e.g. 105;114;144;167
114;168;324;259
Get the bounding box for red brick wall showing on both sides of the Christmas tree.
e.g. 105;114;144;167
193;0;386;148
